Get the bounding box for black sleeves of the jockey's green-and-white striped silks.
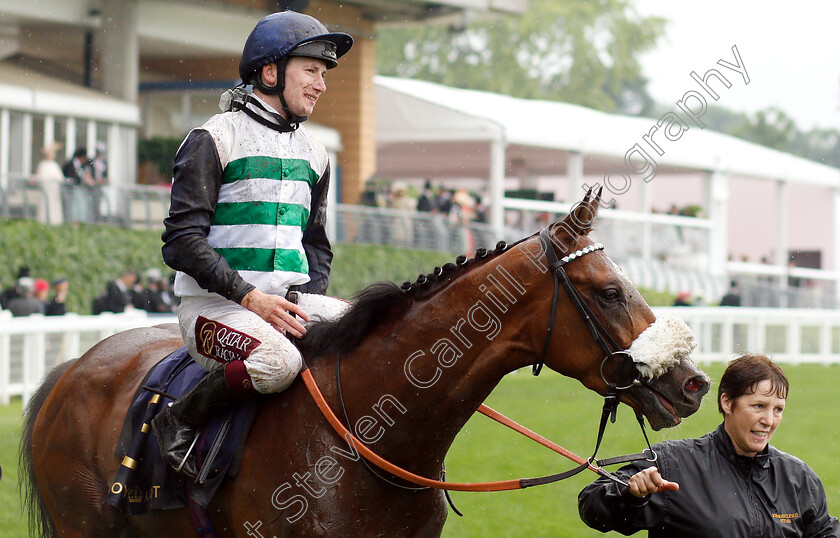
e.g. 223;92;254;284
162;125;332;303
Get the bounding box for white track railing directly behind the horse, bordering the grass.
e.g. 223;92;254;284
0;307;840;405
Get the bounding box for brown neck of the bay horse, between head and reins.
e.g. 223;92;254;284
332;265;533;473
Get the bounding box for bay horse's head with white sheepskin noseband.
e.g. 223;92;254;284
519;186;709;430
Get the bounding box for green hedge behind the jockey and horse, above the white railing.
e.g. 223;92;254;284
0;220;674;314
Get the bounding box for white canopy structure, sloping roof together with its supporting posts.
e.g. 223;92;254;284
374;76;840;302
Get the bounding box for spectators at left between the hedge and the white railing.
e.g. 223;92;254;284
0;266;178;317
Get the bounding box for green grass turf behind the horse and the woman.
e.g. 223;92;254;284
0;364;840;538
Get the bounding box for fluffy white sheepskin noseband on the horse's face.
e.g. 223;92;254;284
627;315;697;379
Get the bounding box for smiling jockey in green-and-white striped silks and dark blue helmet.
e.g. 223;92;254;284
152;11;353;477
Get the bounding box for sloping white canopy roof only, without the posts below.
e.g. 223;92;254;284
374;76;840;187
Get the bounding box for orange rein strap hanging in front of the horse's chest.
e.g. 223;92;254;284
300;368;604;491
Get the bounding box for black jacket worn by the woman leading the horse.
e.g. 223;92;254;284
578;425;840;538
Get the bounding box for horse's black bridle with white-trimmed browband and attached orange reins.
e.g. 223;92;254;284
301;229;657;494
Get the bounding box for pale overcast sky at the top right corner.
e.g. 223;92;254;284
633;0;840;130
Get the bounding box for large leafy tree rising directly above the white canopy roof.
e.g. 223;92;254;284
376;0;665;114
